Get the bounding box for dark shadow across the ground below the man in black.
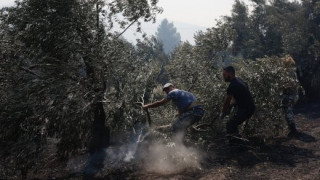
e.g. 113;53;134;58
204;132;320;168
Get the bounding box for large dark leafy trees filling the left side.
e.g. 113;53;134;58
0;0;160;177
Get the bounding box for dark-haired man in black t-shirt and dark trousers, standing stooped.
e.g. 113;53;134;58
220;66;255;136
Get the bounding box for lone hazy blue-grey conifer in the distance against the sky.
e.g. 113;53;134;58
156;19;181;54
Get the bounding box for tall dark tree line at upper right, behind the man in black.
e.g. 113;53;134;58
191;0;320;99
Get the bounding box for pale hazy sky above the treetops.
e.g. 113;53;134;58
0;0;250;43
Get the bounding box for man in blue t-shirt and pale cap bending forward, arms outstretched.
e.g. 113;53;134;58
143;83;204;141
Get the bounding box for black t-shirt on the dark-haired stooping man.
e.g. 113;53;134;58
227;78;254;109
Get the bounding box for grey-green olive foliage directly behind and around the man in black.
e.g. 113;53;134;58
167;44;299;138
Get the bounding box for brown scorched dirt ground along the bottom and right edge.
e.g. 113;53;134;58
30;104;320;180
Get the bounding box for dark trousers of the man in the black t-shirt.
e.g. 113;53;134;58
227;107;254;134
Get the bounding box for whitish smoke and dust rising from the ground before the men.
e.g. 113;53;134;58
67;131;201;175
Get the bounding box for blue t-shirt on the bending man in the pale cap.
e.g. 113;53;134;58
165;89;196;112
